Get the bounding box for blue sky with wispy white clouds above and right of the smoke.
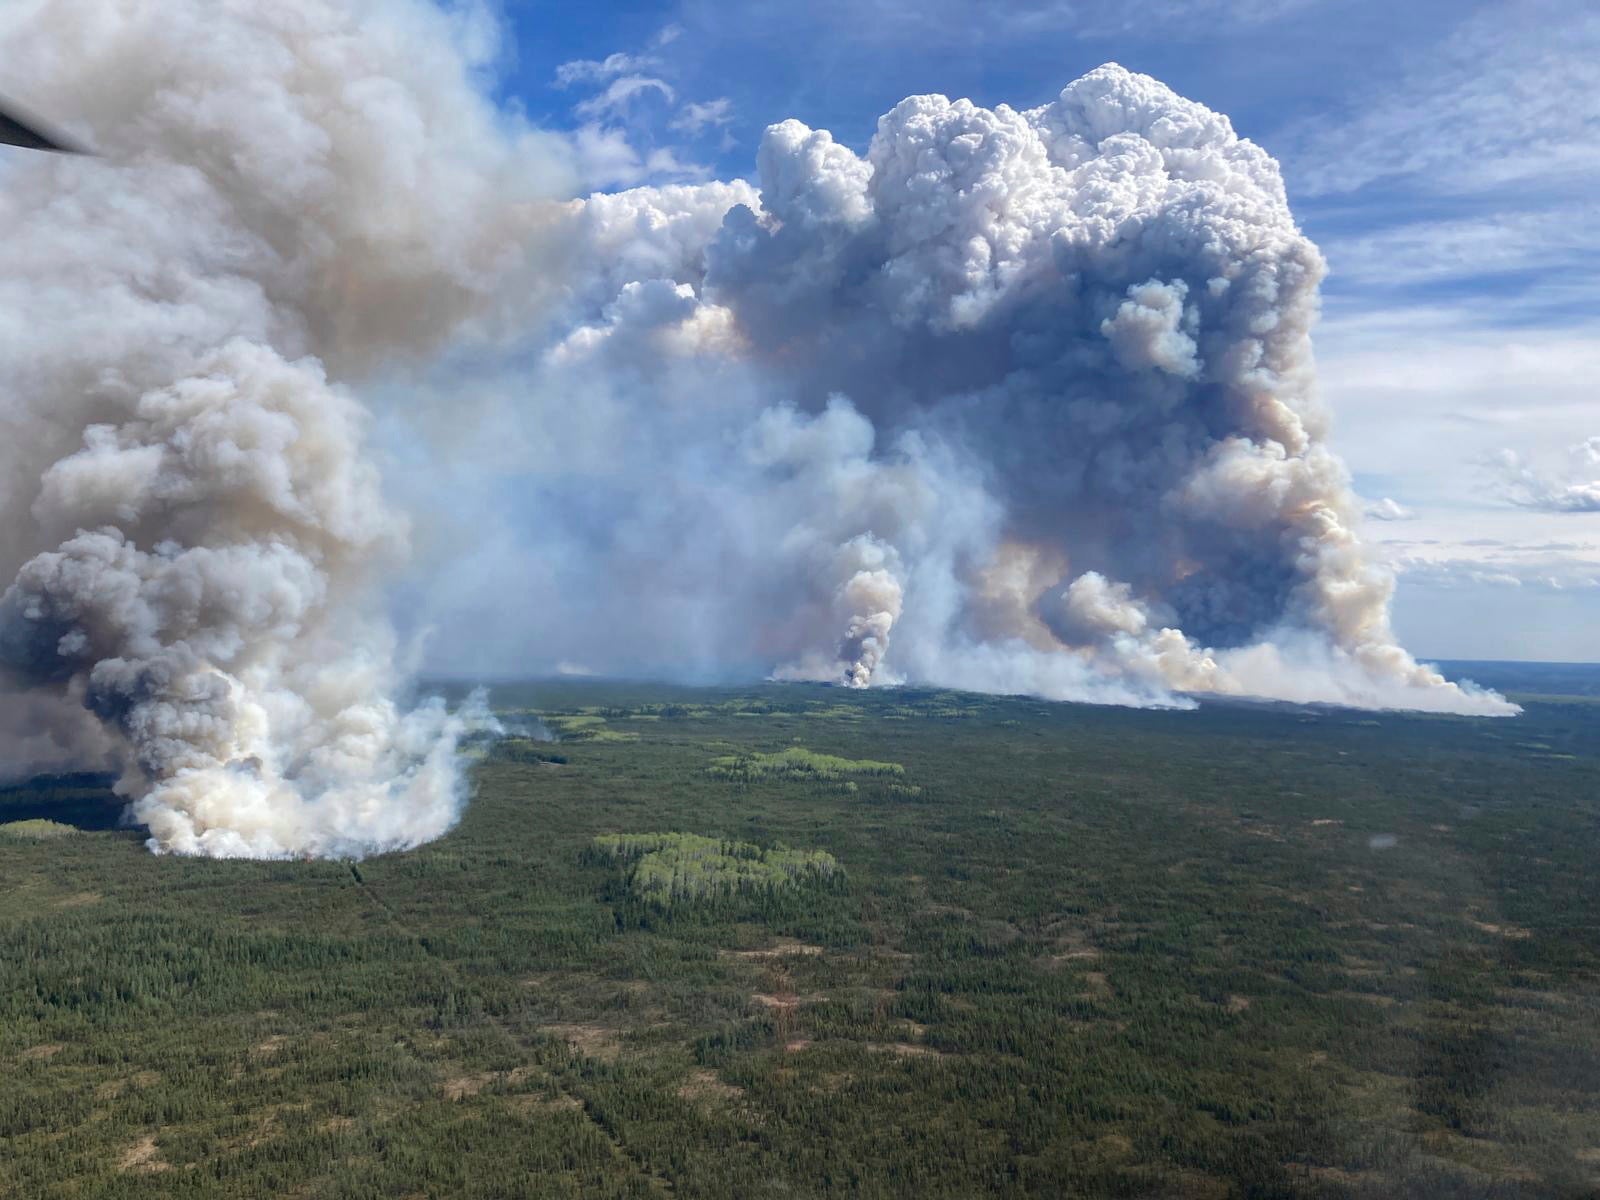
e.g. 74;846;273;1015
486;0;1600;659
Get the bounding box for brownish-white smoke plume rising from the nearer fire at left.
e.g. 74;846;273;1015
0;0;562;856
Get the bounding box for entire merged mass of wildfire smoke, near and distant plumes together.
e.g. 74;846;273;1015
0;9;1510;856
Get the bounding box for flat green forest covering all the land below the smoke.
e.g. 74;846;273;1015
0;669;1600;1200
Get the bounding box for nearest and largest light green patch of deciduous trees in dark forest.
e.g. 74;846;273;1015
594;834;843;907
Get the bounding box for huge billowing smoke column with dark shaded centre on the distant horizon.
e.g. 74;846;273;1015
412;66;1512;712
